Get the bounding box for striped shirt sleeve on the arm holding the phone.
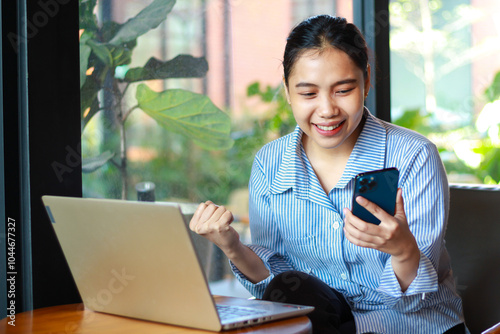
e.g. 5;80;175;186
378;143;449;313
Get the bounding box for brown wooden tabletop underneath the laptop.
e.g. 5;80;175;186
0;304;312;334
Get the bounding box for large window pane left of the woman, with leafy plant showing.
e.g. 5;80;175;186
80;0;352;294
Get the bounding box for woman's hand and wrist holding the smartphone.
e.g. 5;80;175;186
344;189;420;291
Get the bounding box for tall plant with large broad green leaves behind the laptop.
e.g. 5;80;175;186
80;0;233;199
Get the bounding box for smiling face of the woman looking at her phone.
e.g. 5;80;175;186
286;47;370;158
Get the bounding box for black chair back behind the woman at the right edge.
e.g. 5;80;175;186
446;185;500;334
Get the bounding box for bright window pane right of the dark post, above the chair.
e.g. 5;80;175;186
389;0;500;184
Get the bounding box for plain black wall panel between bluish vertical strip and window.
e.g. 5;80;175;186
27;0;82;308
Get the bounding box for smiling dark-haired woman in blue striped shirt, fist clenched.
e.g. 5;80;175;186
190;15;467;333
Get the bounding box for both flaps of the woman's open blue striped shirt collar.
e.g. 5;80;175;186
270;108;387;199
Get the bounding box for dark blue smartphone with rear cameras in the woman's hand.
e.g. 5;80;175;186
352;167;399;225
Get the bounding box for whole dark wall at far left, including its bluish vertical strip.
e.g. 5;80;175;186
0;0;82;316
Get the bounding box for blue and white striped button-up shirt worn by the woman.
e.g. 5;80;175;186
232;111;464;333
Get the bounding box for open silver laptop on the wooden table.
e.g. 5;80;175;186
42;196;314;331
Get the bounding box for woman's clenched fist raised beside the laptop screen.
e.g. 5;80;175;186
189;201;240;253
